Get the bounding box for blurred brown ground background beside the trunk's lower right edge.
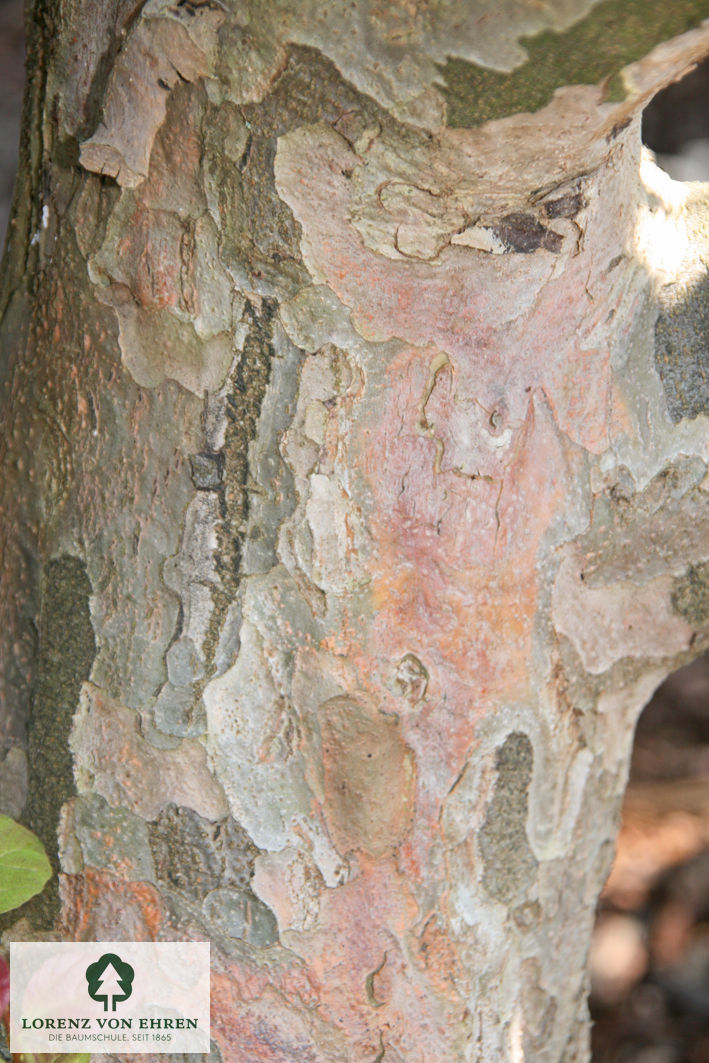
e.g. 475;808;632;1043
590;657;709;1063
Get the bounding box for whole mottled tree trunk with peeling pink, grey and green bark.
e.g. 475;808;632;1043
0;0;709;1063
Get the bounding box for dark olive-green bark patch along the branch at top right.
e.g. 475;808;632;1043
439;0;709;129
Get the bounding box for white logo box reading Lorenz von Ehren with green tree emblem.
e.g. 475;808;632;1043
10;941;209;1056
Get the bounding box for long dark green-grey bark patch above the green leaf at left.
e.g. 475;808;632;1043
26;556;96;919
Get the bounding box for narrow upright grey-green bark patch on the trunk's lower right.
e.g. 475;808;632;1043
478;731;537;905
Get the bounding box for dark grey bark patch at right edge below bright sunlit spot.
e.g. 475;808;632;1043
655;274;709;424
